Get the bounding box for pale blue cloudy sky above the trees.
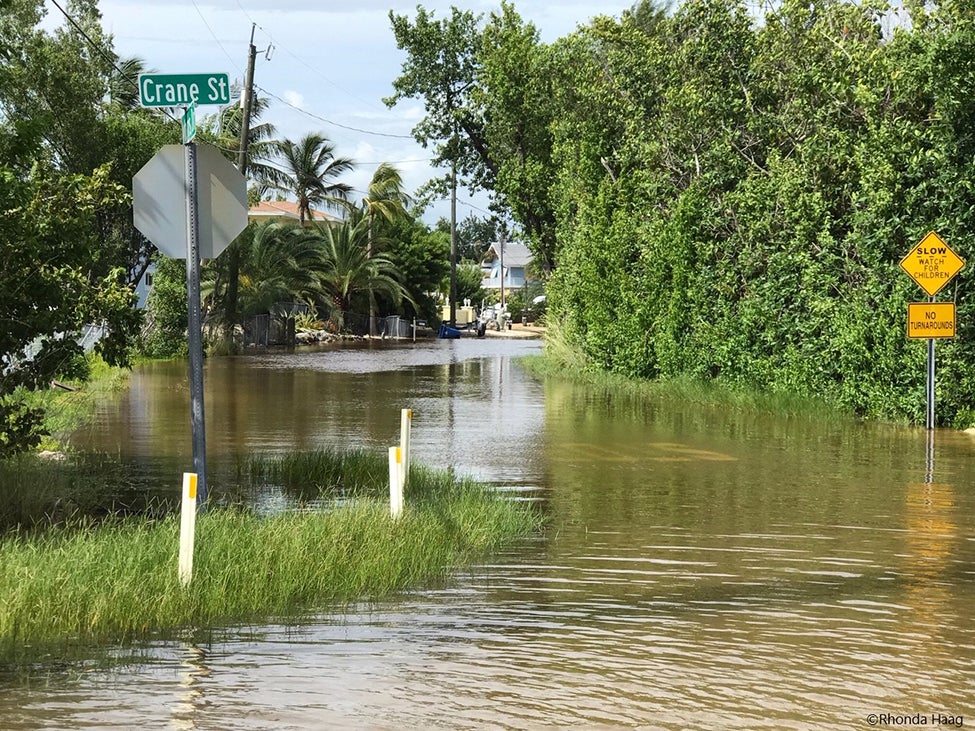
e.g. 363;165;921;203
46;0;635;224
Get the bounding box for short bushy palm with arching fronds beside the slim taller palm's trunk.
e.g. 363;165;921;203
319;218;412;327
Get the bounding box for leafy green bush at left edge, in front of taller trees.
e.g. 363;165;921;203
0;166;141;456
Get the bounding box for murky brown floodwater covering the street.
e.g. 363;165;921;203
0;339;975;730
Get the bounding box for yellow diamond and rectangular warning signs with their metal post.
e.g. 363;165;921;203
901;231;965;432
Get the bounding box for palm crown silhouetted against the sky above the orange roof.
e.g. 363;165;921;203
269;133;355;223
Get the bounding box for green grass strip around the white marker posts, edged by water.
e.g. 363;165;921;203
0;453;539;659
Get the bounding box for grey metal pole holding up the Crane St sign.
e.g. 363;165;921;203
184;142;207;505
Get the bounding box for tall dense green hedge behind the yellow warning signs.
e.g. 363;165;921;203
536;0;975;426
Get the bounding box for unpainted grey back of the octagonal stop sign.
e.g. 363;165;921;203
132;145;247;259
